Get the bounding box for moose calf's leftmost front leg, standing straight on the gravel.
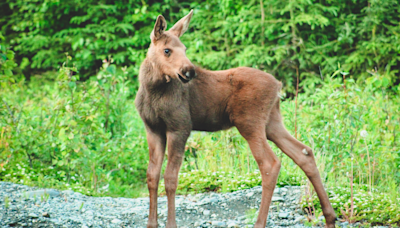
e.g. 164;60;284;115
147;129;166;228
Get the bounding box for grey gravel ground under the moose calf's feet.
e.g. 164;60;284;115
0;182;376;228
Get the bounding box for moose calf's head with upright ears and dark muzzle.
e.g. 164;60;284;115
147;10;196;83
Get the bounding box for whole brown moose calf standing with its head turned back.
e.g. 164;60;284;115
135;11;336;228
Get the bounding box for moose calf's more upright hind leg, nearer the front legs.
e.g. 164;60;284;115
236;124;281;228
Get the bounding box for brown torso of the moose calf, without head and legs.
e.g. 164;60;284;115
137;67;281;131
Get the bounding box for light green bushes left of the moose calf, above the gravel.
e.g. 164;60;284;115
0;56;147;198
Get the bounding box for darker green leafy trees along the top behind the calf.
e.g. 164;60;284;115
0;0;400;87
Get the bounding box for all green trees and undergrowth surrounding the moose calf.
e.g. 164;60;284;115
0;0;400;225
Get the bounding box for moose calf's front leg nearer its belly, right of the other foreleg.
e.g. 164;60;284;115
164;131;190;228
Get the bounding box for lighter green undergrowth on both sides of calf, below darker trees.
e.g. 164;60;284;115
0;52;400;224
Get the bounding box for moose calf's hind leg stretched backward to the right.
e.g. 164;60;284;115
266;108;336;228
